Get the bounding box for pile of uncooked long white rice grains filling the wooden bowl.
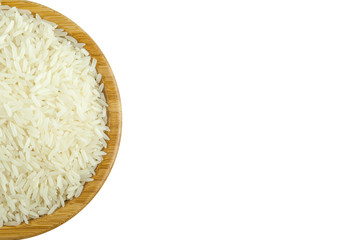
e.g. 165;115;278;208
0;6;109;227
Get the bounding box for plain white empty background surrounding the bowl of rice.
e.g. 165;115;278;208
30;0;360;240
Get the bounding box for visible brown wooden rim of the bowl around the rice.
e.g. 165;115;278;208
0;0;122;240
